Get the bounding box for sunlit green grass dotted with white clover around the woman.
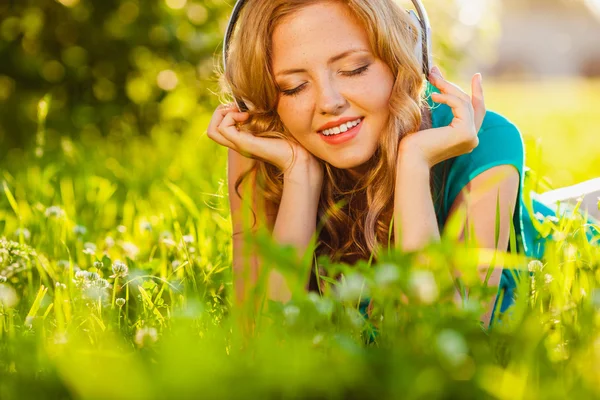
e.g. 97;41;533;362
0;83;600;399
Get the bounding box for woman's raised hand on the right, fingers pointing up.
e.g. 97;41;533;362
398;67;486;168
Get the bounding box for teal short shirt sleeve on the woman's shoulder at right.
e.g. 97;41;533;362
445;111;525;215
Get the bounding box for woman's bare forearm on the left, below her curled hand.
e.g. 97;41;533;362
268;162;323;301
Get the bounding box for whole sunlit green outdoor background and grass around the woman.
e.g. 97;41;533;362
0;0;600;400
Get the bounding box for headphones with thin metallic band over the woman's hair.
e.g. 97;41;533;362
223;0;433;112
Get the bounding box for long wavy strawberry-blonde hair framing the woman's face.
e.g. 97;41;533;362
219;0;447;264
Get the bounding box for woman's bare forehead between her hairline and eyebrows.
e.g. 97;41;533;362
272;2;370;71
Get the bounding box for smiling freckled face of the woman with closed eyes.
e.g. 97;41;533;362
272;2;394;171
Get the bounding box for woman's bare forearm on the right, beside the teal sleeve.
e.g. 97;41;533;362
394;152;440;251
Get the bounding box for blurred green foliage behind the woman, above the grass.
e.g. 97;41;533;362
0;0;498;155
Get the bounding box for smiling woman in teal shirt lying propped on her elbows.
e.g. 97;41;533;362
207;0;600;325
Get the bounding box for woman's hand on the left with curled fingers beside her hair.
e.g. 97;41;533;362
207;103;320;173
